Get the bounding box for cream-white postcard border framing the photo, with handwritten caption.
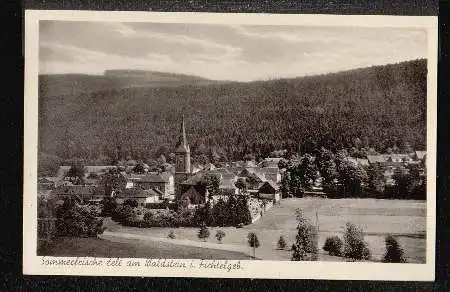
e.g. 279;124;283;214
23;10;438;281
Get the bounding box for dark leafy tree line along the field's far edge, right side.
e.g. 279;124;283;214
279;148;426;200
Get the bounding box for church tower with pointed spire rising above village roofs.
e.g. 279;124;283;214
175;117;192;188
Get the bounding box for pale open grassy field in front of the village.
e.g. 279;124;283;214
103;199;426;263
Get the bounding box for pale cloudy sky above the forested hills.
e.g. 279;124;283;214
39;21;427;82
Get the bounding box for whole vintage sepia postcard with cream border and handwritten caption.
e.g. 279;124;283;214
23;11;437;281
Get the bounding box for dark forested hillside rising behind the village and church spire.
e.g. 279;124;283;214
39;60;427;167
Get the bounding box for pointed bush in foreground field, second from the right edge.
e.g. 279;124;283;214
344;223;370;260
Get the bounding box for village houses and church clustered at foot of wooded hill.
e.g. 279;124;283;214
38;120;426;213
